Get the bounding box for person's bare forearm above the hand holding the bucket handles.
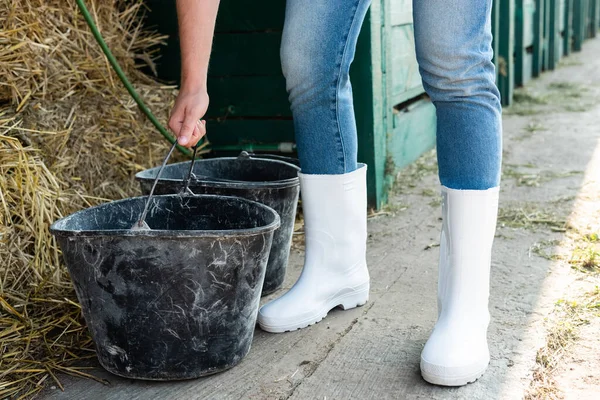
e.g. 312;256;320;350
177;0;219;91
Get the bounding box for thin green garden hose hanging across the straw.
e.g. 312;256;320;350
75;0;192;157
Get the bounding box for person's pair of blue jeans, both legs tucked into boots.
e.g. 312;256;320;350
281;0;502;190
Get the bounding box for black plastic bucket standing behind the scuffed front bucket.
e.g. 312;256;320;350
135;156;300;295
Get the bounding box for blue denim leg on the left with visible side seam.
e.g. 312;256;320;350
281;0;370;175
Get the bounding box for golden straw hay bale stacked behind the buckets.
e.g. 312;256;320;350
0;0;188;398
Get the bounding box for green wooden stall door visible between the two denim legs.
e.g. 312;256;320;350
351;0;436;207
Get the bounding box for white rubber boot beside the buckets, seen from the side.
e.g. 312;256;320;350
258;164;369;333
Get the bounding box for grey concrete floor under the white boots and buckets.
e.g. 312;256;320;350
40;39;600;400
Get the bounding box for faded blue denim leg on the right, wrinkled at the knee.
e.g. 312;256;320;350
413;0;502;190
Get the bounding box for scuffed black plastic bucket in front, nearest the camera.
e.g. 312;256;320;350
50;195;279;380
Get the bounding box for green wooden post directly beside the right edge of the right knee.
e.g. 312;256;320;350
498;0;515;106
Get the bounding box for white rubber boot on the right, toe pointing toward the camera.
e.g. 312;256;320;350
421;187;498;386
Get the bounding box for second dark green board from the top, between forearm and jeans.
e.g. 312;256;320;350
209;32;282;76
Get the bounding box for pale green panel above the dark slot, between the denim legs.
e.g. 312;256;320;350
390;25;424;105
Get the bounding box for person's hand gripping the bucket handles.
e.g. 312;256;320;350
169;88;209;148
